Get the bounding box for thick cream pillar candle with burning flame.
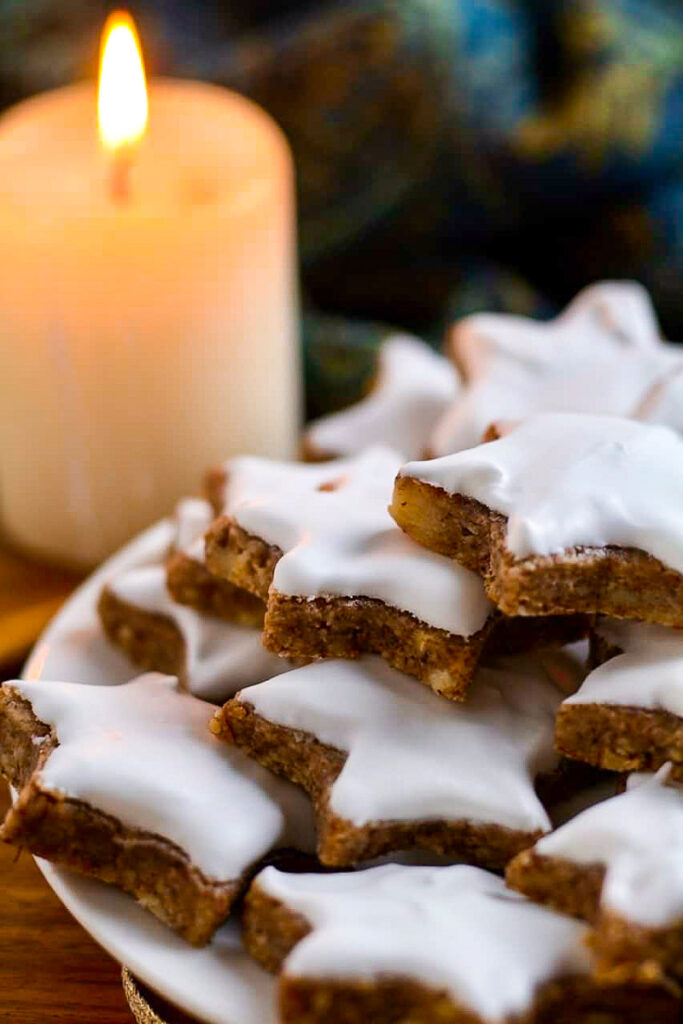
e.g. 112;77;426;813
0;15;299;565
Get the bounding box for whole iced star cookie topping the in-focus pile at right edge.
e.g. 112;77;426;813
391;414;683;627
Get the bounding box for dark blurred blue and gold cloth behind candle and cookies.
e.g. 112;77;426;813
0;0;683;415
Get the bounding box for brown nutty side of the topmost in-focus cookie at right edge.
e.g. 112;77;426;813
390;476;683;626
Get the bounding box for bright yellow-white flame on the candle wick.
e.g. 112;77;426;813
97;10;147;153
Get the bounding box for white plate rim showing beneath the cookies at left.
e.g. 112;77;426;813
21;521;278;1024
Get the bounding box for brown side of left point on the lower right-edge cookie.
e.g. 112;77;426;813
505;850;605;924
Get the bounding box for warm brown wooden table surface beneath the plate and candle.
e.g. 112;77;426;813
0;542;200;1024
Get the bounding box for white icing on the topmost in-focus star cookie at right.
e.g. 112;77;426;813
400;414;683;572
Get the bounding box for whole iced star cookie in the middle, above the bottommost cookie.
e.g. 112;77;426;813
214;657;561;868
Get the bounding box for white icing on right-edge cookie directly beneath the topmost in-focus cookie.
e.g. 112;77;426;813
565;618;683;717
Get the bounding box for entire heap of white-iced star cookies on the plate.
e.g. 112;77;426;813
0;284;683;1024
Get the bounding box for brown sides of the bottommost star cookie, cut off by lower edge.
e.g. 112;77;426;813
243;881;679;1024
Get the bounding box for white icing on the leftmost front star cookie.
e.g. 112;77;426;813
7;674;312;881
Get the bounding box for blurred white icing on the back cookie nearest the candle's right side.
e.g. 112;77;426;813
305;334;460;459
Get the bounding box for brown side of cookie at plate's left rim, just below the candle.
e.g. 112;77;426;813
97;587;186;685
